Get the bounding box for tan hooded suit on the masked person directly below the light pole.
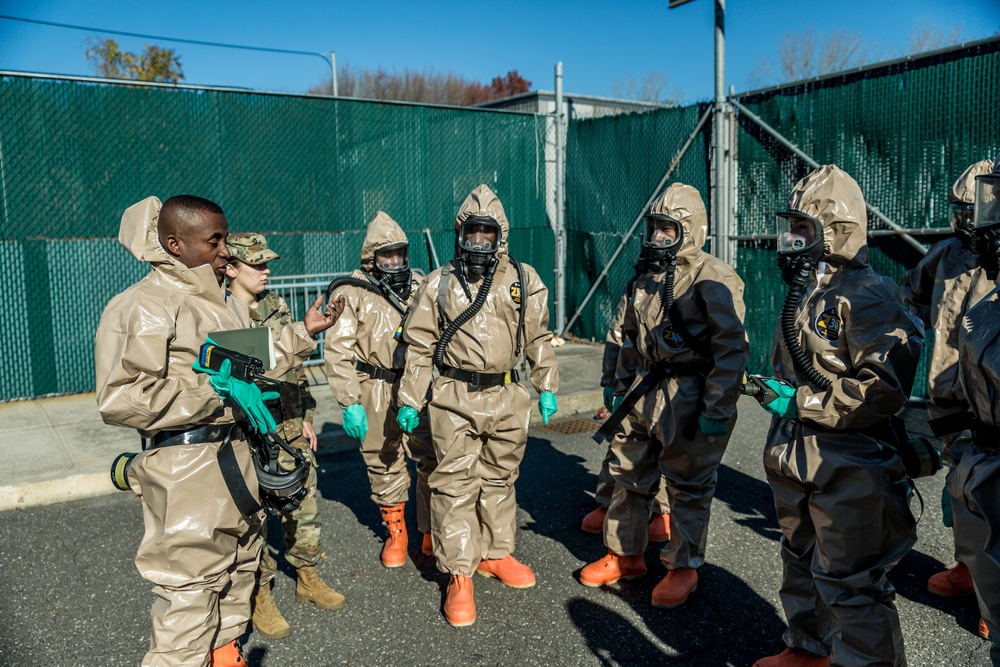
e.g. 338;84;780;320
604;183;749;569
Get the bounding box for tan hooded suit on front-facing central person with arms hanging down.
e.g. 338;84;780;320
399;185;559;577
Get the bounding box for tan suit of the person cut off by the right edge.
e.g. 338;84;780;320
948;287;1000;665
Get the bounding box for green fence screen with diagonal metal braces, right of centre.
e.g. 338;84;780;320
566;38;1000;393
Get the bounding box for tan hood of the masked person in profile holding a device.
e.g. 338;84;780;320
788;164;868;266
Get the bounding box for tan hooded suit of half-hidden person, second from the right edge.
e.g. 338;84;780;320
902;160;994;460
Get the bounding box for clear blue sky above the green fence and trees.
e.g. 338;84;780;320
0;0;1000;100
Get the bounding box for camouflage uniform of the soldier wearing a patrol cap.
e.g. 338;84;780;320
242;292;322;585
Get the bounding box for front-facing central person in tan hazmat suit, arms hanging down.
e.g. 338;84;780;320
398;185;559;626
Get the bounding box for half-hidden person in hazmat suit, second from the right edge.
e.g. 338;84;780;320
902;160;995;597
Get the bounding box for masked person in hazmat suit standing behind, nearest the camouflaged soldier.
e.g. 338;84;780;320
323;211;436;568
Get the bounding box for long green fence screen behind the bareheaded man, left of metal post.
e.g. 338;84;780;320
0;76;553;400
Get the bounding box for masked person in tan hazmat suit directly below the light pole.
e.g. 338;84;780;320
580;183;749;608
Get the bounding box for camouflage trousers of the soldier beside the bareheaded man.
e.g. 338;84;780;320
259;435;321;585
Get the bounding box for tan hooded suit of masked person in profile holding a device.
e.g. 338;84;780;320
764;165;923;666
